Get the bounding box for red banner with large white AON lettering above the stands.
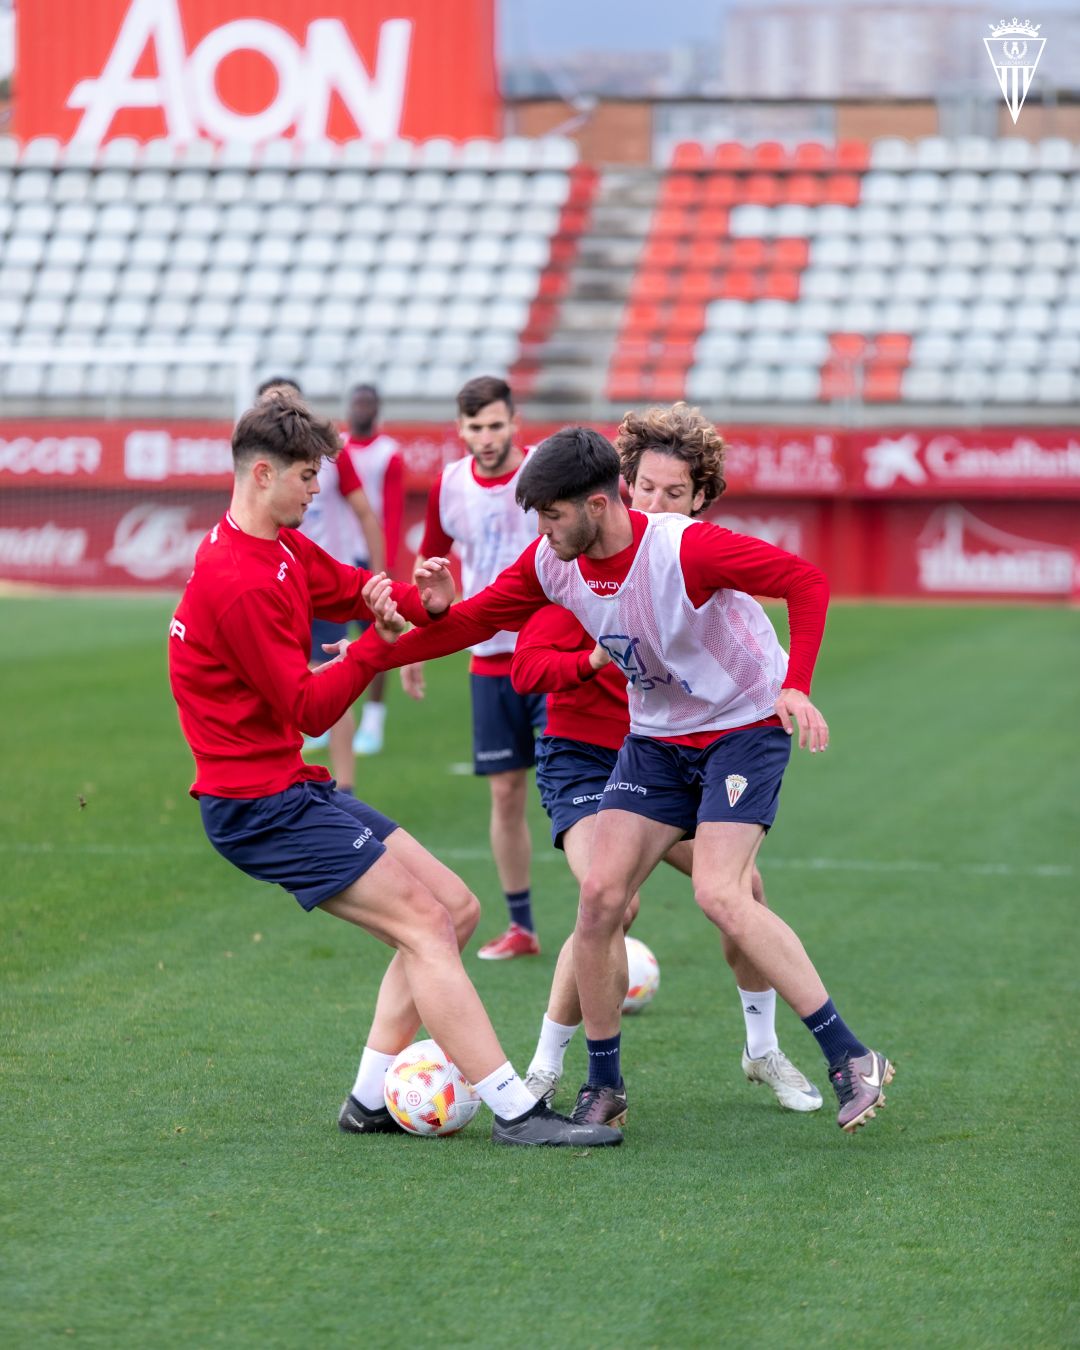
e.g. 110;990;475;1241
15;0;498;146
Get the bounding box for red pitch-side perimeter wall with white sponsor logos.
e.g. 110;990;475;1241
0;420;1080;599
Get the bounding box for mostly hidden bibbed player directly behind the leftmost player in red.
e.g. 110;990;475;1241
258;375;386;792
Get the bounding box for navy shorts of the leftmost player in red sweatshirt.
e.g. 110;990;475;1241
198;782;397;910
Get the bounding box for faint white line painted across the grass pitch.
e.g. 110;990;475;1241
0;841;1076;878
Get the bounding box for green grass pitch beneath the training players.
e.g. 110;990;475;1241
0;597;1080;1350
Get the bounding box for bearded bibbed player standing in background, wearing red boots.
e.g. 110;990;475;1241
417;375;545;961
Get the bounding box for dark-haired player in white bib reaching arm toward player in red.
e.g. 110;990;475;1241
361;404;894;1133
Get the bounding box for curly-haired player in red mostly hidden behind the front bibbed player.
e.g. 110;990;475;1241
510;423;821;1111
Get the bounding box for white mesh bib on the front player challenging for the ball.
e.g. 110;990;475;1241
536;514;787;737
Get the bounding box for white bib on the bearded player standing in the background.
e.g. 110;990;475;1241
439;455;537;656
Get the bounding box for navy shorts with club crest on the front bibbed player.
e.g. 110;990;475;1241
599;726;791;836
